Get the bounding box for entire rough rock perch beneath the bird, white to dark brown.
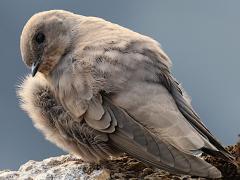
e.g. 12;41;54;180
0;143;240;180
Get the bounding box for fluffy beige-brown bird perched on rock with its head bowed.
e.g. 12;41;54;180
17;10;234;178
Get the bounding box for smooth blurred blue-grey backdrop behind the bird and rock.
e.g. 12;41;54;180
0;0;240;169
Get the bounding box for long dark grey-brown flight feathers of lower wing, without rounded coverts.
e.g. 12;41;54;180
103;98;221;177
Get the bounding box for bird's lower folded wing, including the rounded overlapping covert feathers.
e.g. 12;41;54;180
84;97;221;177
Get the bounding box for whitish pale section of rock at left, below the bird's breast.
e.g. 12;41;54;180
0;155;110;180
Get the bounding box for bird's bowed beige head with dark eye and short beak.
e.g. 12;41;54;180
20;10;73;76
